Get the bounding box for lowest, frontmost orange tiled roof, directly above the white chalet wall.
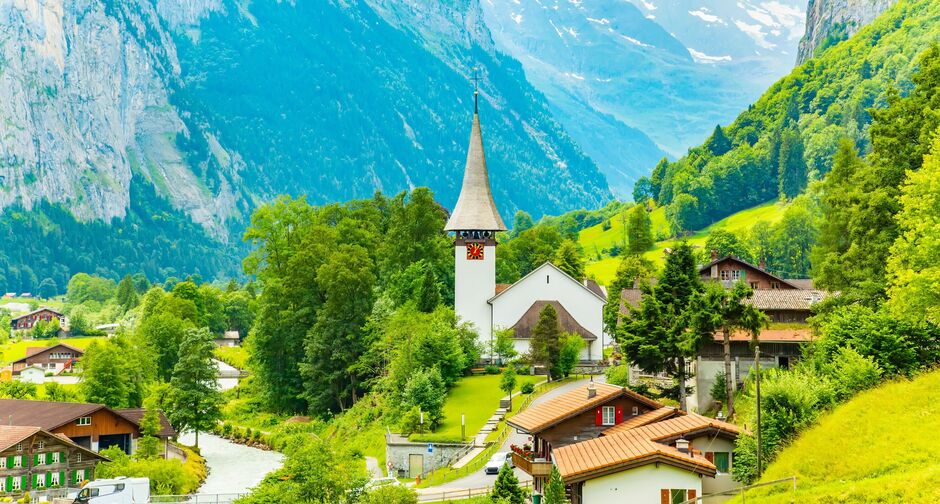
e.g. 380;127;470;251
552;431;717;483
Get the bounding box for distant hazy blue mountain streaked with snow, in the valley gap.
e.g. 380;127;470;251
481;0;804;195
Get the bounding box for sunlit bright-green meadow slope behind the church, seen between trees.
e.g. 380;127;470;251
578;201;788;284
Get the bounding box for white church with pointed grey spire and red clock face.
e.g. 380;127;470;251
444;92;611;362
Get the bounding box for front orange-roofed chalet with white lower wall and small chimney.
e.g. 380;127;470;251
553;408;740;504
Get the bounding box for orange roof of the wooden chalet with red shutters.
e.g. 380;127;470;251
506;383;663;434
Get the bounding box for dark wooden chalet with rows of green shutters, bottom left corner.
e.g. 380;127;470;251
0;425;108;498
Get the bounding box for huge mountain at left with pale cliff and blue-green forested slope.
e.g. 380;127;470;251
0;0;610;290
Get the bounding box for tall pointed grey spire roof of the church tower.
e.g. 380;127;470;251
444;113;506;231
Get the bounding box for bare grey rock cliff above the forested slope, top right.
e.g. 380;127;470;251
796;0;897;65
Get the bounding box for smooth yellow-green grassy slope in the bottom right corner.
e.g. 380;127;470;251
734;371;940;504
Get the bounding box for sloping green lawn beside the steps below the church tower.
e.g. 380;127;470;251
411;375;545;442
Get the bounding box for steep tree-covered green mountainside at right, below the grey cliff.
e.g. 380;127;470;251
638;0;940;232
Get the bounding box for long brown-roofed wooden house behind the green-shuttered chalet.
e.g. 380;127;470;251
0;399;176;454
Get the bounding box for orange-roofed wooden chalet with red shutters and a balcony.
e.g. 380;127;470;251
506;383;663;491
